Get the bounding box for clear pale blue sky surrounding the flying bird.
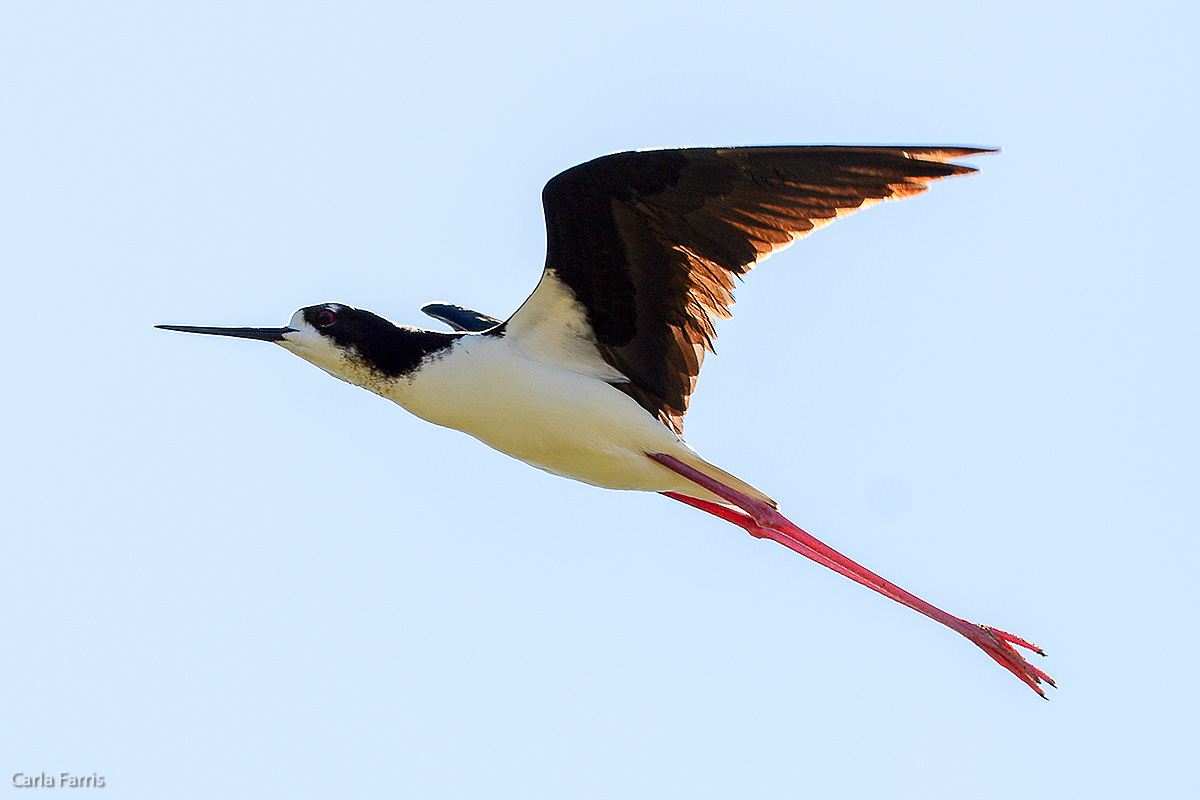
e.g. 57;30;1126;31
0;1;1200;800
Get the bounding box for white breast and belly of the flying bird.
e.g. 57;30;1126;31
374;336;707;497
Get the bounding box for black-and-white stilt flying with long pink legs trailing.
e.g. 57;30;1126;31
158;146;1054;697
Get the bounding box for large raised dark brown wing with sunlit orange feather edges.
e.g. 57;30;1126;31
535;146;989;432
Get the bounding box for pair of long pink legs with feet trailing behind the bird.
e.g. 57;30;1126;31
647;453;1055;697
